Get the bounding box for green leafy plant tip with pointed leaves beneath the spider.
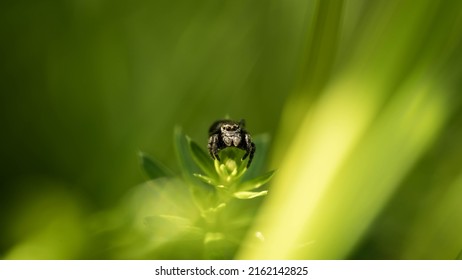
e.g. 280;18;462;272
140;128;274;259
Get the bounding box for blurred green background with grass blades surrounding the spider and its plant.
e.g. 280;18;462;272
0;0;462;259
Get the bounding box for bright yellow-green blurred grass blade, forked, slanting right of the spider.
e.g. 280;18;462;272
241;75;448;259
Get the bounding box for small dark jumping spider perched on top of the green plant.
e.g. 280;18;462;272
208;120;255;167
